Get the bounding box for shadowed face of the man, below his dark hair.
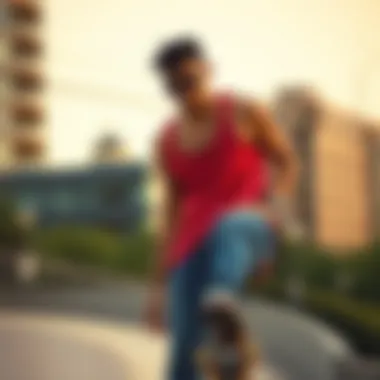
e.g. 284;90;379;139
164;59;210;105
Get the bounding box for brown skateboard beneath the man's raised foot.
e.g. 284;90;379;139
196;309;259;380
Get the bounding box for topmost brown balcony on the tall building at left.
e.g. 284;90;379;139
8;0;42;25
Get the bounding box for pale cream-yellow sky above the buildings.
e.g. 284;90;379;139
43;0;380;162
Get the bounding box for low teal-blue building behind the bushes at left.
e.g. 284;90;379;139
0;163;146;229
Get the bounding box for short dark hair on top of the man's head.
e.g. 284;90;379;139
154;37;204;71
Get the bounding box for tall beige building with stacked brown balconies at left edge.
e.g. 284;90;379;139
0;0;46;167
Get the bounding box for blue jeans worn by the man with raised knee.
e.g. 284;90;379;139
169;211;274;380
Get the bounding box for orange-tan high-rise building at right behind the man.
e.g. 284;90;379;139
275;89;380;248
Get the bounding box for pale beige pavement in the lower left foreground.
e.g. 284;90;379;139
0;311;282;380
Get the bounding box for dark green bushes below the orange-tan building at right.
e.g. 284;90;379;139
253;240;380;355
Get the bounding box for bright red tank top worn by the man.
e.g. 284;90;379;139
161;95;267;268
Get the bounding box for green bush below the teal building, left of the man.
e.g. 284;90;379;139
34;226;152;276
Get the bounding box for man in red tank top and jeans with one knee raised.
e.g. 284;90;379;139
147;38;298;380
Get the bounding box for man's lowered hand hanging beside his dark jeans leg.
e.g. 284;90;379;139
145;285;166;332
